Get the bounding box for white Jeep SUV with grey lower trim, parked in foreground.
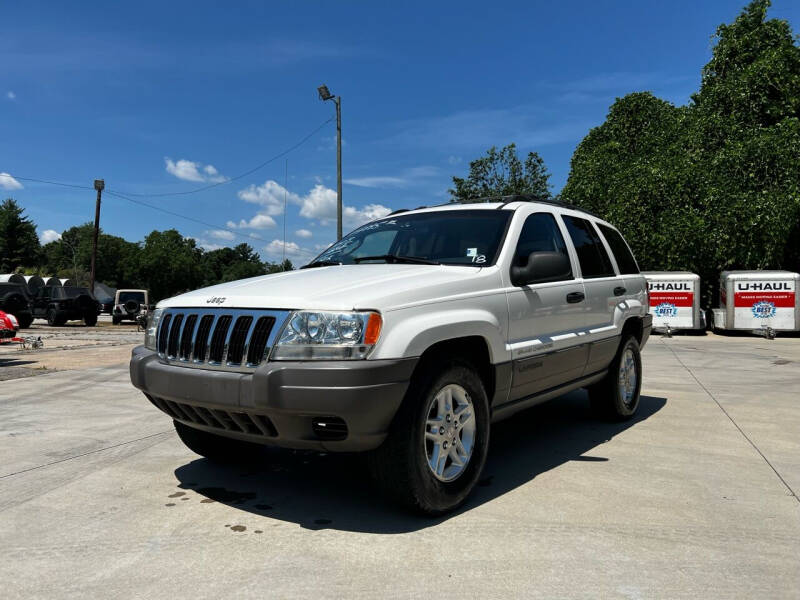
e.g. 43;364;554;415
130;197;652;514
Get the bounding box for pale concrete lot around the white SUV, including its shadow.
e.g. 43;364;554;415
0;335;800;600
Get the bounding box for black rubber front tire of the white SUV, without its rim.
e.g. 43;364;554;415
367;362;490;516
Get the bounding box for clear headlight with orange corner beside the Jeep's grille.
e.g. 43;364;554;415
271;310;383;360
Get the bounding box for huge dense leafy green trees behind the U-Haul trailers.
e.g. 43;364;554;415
562;0;800;304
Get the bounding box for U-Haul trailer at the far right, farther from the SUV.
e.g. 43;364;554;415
714;271;800;337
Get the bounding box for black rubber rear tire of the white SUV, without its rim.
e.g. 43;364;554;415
589;335;642;421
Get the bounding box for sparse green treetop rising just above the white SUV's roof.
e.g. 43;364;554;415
448;144;551;202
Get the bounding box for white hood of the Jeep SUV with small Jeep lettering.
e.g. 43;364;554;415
158;264;500;311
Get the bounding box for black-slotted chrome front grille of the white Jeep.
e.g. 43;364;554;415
157;308;289;372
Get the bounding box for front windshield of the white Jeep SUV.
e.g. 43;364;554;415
310;210;511;266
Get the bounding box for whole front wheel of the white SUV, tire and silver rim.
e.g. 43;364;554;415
369;362;489;515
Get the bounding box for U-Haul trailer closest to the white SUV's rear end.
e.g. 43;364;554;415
642;271;706;333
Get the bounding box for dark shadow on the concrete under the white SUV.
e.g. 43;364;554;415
175;390;667;534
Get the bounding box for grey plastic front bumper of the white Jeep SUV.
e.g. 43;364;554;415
130;346;418;452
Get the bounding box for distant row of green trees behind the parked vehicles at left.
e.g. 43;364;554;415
0;199;294;300
